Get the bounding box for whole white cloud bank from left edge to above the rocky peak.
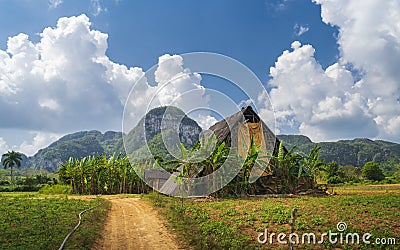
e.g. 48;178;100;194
0;15;213;154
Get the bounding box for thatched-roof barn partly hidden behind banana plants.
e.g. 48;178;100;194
156;106;312;195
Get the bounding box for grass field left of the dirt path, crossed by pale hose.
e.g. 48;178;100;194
0;193;109;249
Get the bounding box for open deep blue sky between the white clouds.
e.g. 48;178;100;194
0;0;339;82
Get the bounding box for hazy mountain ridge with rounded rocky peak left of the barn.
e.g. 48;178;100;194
11;107;201;172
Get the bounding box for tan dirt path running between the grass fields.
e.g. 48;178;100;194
94;198;178;250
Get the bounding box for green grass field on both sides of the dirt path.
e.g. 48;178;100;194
0;185;400;249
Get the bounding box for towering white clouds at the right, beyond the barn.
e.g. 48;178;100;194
268;0;400;142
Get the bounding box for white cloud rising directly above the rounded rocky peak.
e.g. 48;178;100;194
124;54;213;132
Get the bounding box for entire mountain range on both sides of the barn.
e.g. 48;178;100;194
3;107;400;172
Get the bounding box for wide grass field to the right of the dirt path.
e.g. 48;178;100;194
150;185;400;249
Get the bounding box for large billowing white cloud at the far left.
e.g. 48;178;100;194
0;15;143;133
